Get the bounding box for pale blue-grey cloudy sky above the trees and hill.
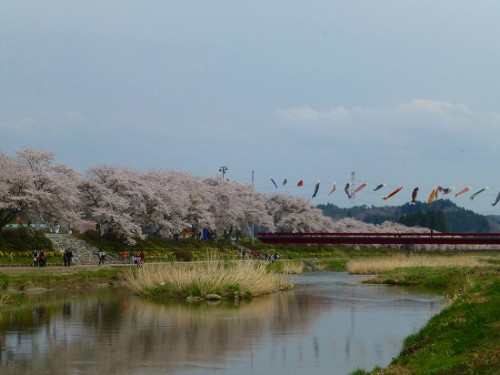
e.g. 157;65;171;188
0;0;500;214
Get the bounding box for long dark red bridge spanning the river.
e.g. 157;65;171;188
256;232;500;245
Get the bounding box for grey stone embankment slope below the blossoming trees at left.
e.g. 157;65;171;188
45;233;116;264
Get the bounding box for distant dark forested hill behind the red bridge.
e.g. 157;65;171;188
317;199;500;232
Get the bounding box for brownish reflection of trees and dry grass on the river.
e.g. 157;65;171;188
0;292;330;375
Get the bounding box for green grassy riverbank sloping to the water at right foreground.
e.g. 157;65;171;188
348;263;500;375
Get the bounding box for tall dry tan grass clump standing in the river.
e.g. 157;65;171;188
128;260;292;298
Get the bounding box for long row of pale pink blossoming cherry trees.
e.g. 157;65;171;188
0;149;340;243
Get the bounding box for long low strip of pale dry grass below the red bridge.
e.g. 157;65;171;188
347;255;487;275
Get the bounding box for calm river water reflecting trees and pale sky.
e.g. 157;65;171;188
0;272;443;375
